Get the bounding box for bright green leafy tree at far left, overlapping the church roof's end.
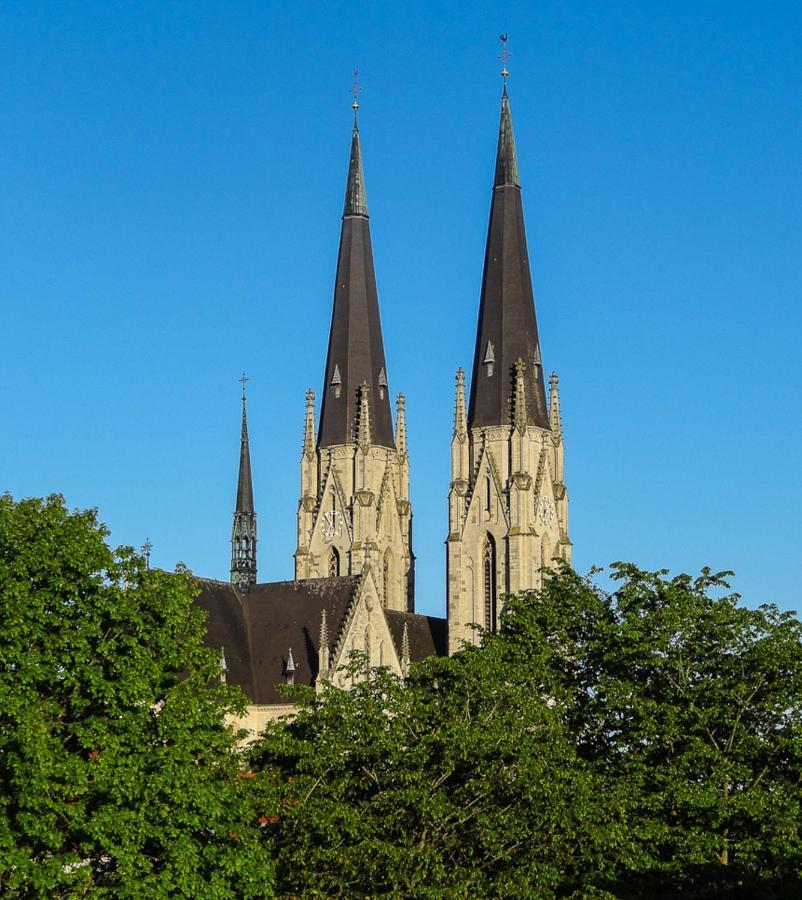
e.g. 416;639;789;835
0;495;272;897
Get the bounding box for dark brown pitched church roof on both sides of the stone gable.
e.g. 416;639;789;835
195;575;446;704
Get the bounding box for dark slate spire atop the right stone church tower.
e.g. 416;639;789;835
468;86;549;428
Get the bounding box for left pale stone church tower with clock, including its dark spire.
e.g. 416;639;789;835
295;102;414;611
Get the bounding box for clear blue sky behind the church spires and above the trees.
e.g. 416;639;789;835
0;0;802;614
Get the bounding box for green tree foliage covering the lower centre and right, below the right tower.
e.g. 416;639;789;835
253;564;802;898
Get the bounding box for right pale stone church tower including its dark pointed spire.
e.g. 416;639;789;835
446;82;571;653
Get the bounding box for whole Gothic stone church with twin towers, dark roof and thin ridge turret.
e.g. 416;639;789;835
197;70;571;731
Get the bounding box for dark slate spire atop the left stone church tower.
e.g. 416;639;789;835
318;112;395;447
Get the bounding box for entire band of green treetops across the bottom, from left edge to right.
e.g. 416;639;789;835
0;496;802;900
